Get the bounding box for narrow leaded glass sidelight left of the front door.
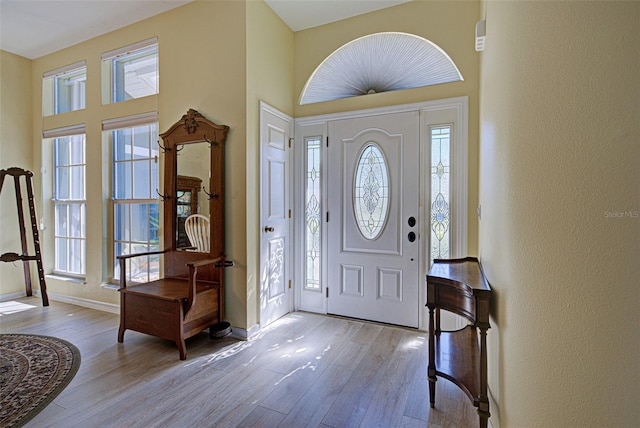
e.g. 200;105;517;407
304;137;321;291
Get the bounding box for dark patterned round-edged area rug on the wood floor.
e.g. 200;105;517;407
0;334;80;427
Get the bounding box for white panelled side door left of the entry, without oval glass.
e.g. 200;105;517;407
260;103;293;327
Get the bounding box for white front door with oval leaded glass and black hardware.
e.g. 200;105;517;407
327;111;420;327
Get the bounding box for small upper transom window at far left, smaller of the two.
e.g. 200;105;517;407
42;61;87;116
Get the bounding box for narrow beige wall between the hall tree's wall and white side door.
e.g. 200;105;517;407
245;1;294;327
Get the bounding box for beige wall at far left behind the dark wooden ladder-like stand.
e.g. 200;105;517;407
0;51;34;295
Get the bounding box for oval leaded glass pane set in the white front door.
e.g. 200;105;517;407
353;143;389;239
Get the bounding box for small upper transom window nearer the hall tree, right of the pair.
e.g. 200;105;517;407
102;38;160;104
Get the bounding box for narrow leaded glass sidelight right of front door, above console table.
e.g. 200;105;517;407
430;126;451;264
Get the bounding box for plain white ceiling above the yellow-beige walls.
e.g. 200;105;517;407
0;0;411;59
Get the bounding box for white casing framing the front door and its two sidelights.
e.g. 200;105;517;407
294;97;469;330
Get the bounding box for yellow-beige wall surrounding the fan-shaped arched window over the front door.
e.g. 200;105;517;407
294;0;480;255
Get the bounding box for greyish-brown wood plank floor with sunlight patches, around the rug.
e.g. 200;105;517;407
0;298;478;428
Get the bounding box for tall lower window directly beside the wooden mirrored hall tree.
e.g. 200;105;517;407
110;118;160;282
